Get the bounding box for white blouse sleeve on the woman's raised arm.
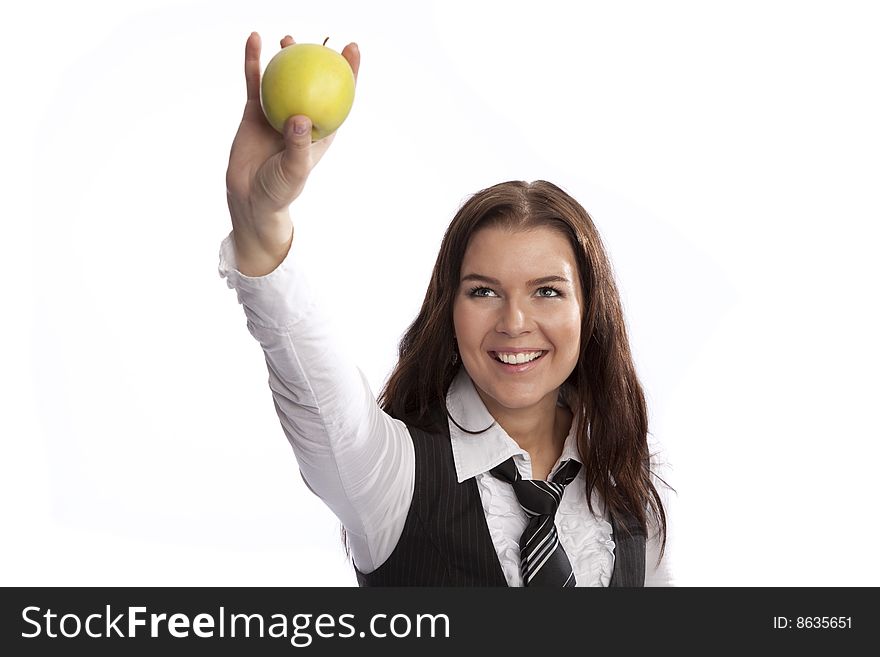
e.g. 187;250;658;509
218;233;415;573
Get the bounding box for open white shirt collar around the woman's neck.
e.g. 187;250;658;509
446;367;581;483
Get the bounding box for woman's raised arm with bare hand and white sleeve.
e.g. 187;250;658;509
220;33;414;572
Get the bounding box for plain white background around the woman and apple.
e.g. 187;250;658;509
0;0;880;586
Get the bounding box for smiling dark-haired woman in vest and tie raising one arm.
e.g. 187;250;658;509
220;33;671;587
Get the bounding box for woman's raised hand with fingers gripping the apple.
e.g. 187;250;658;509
226;32;361;223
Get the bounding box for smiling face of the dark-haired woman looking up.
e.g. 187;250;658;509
452;227;583;412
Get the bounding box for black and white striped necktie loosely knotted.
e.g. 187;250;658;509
490;456;581;587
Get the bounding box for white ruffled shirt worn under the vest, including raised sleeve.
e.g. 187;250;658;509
218;233;673;586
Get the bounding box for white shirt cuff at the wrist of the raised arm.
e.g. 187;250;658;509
217;231;314;328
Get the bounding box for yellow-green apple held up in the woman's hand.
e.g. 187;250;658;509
260;41;354;141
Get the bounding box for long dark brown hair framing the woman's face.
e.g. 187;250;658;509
344;180;666;556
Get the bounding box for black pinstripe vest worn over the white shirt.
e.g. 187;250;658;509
355;408;645;586
